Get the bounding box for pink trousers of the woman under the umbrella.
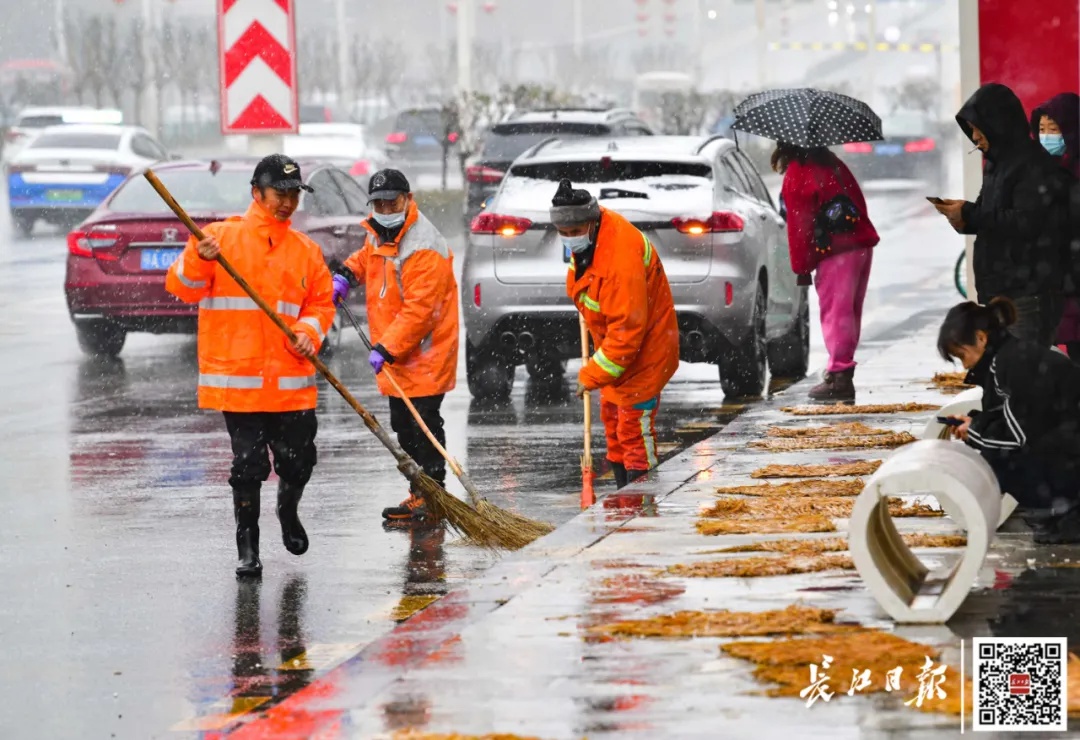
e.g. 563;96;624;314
813;248;874;373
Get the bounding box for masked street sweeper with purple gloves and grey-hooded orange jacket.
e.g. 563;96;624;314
333;170;459;524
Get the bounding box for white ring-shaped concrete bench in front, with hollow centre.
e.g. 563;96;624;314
848;440;1001;623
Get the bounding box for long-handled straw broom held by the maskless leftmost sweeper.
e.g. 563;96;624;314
144;170;522;550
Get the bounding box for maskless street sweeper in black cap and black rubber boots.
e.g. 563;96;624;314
165;154;334;576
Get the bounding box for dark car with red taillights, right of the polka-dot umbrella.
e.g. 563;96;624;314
843;113;956;193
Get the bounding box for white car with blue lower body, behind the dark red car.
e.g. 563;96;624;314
8;124;168;236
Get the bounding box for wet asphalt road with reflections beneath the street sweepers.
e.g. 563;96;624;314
0;180;959;738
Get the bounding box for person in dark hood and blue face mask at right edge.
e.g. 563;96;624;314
1031;93;1080;362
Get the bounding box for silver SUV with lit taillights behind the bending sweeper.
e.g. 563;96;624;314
461;136;810;399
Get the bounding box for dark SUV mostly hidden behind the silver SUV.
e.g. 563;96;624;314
464;108;652;224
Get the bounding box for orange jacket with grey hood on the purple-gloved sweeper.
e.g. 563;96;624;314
345;201;458;398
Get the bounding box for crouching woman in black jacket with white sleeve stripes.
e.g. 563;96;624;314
937;298;1080;544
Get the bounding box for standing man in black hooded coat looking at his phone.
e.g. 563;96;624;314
934;83;1068;346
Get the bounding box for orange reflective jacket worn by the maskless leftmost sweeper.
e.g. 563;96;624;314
165;202;335;412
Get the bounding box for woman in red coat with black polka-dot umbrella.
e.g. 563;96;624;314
733;89;881;403
